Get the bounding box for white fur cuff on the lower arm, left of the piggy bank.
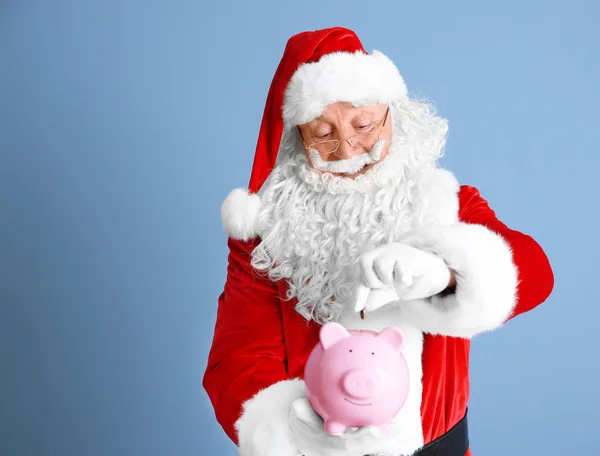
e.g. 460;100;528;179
235;379;306;456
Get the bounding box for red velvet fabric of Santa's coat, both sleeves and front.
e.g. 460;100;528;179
203;186;554;456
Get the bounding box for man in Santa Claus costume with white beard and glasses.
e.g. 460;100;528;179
203;27;553;456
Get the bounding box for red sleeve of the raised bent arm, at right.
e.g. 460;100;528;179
459;186;554;319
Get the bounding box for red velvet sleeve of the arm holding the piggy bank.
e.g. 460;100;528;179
203;239;288;444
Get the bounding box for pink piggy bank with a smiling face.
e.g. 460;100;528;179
304;323;409;435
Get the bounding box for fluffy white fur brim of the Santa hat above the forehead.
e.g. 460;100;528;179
283;51;407;126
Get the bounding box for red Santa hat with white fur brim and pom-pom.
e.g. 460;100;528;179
221;27;407;240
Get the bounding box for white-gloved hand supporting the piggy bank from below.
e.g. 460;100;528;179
290;398;381;456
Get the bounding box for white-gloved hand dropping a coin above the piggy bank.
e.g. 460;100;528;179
354;243;453;312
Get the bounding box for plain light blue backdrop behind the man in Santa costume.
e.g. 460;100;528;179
0;0;600;456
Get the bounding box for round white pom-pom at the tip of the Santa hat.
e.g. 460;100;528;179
221;188;260;241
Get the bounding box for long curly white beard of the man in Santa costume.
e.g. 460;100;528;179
252;102;447;323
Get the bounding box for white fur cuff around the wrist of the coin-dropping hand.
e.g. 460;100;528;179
401;223;518;338
